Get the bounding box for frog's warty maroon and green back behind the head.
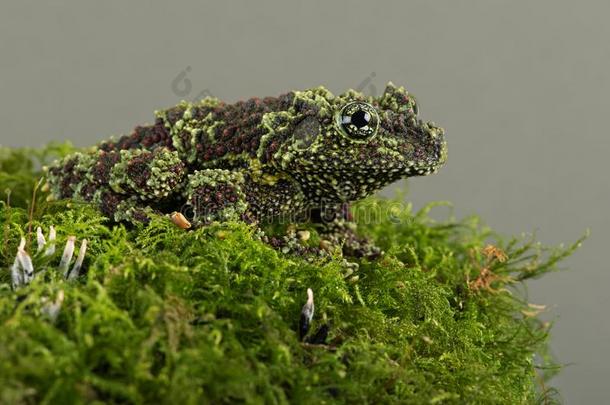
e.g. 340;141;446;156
99;92;294;168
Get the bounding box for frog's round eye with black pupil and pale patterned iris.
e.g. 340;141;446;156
337;101;379;142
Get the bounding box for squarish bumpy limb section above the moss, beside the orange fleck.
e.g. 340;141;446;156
186;169;247;226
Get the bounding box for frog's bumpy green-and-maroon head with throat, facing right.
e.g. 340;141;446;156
259;83;447;202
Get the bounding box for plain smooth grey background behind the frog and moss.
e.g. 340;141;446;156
0;0;610;404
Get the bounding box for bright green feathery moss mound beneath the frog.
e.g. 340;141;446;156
0;146;580;404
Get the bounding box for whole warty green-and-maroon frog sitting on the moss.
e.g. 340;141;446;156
48;83;446;254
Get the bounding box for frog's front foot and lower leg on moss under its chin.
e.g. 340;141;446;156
312;203;382;258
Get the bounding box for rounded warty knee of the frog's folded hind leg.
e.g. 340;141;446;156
109;148;186;201
